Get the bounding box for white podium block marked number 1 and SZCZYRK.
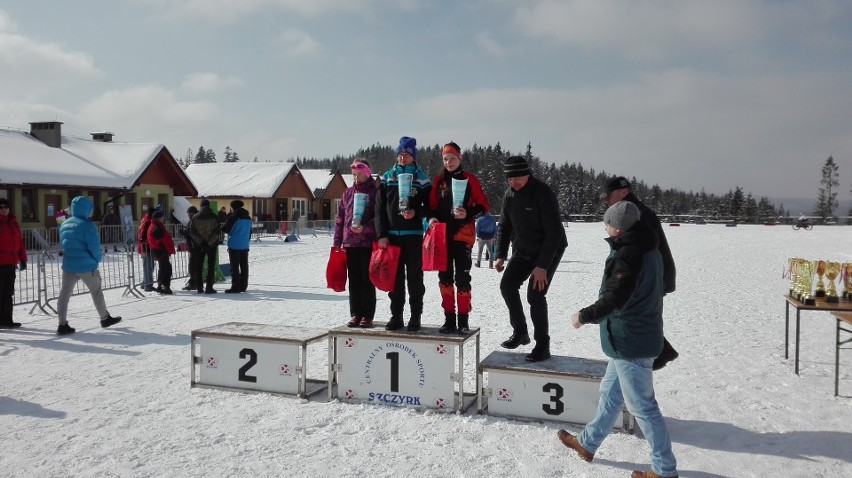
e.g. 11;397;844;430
328;323;479;411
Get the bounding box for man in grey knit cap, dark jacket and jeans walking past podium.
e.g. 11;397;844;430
557;201;677;478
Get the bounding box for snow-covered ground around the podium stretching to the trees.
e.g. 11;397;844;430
0;223;852;478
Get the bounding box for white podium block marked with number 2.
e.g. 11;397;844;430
190;322;328;398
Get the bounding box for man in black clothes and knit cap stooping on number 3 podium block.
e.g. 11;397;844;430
494;156;568;362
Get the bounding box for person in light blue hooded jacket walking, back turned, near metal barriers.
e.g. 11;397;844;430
56;196;121;335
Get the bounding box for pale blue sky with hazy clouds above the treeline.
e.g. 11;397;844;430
0;0;852;203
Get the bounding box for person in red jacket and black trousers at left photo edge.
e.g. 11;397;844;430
0;198;27;329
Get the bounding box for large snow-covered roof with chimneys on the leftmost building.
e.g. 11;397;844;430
0;129;165;189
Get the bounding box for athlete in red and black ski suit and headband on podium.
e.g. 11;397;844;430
429;141;490;335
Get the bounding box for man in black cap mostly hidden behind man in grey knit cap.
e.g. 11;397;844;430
601;176;678;370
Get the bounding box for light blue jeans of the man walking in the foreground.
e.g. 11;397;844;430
577;358;677;476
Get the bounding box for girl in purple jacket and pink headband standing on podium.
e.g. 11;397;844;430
332;158;378;328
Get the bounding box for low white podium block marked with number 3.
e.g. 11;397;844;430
477;351;635;433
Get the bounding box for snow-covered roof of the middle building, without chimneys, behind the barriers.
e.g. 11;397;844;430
186;162;295;198
